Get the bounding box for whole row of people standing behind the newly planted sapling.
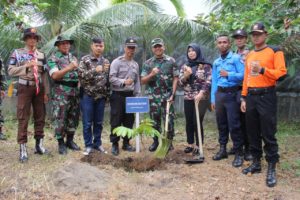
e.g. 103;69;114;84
0;23;286;187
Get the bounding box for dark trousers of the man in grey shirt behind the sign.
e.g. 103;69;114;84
110;91;134;143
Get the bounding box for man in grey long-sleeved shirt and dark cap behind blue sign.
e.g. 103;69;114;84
109;37;140;155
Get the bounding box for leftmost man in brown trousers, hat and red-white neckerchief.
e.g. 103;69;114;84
8;28;48;162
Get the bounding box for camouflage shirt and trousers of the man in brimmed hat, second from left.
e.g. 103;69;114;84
48;51;80;139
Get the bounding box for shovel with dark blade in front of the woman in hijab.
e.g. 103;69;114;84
185;101;204;164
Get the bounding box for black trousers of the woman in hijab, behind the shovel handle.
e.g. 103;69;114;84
184;100;208;146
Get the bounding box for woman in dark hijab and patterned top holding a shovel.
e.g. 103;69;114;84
179;43;212;155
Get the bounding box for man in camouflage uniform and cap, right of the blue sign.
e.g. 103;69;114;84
141;38;179;151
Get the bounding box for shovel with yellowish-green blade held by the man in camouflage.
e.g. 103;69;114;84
154;101;172;158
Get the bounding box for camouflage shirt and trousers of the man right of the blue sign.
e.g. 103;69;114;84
141;55;179;139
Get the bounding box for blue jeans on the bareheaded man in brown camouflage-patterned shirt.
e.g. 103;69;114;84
80;94;105;148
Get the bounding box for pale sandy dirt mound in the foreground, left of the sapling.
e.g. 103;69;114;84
53;162;110;193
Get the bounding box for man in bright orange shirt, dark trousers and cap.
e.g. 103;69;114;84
241;22;287;187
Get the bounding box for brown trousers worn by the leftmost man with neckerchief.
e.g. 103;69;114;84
17;84;46;144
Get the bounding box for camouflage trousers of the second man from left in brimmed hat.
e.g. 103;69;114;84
52;95;80;139
